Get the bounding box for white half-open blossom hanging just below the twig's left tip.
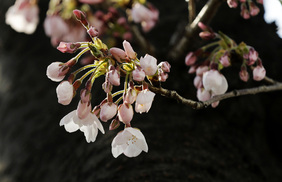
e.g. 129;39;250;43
135;89;156;113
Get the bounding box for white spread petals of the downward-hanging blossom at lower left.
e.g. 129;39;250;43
60;110;105;143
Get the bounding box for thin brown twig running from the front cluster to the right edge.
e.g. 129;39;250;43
149;82;282;109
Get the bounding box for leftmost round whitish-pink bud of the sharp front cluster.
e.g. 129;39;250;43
46;62;69;82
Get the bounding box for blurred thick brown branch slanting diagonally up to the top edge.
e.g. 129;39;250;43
168;0;223;60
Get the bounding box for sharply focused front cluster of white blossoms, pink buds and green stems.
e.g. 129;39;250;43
46;10;170;157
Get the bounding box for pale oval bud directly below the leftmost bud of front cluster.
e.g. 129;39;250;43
56;81;74;105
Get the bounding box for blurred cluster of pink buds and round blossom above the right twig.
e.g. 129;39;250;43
185;22;266;107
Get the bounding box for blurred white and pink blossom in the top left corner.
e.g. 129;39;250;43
6;0;39;34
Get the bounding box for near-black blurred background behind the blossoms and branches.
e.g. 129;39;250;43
0;0;282;182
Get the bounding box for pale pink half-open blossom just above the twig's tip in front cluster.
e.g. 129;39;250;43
140;54;158;76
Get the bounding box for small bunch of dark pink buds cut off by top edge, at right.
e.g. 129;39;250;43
227;0;263;19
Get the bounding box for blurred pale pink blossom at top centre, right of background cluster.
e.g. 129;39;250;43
131;3;159;32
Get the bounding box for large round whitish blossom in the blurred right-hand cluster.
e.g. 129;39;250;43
203;69;228;95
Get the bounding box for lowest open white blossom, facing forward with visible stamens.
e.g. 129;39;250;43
112;127;148;158
